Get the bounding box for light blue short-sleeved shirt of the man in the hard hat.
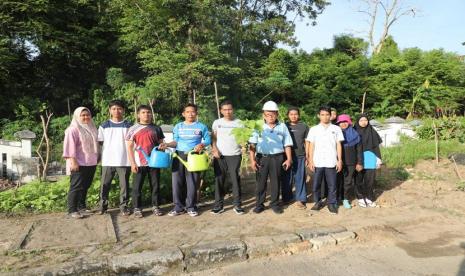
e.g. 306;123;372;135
249;122;293;154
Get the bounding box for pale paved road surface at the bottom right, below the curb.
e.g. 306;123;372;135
190;245;465;276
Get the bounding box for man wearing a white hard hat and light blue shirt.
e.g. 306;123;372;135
249;101;292;214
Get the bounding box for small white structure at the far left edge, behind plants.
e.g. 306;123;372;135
0;130;38;182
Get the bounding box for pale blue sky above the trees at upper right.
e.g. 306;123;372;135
285;0;465;55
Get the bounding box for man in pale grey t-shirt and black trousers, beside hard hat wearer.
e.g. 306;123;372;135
211;101;244;215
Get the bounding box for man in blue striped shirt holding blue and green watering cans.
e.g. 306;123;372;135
159;104;211;217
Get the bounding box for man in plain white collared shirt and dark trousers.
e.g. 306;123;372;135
306;107;344;214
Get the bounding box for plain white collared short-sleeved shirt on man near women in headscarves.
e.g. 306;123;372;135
306;124;344;168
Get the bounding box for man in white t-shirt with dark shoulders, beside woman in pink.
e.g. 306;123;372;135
98;100;132;216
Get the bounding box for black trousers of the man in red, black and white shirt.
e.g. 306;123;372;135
132;166;160;209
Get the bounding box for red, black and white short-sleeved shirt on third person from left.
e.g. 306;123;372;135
126;124;165;166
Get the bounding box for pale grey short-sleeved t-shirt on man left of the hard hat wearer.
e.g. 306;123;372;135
212;118;242;156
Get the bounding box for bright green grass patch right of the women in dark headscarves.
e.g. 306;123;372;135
381;137;465;168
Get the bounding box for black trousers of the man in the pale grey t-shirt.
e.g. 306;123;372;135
213;155;242;208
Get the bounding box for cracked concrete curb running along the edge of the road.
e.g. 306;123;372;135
16;226;357;276
